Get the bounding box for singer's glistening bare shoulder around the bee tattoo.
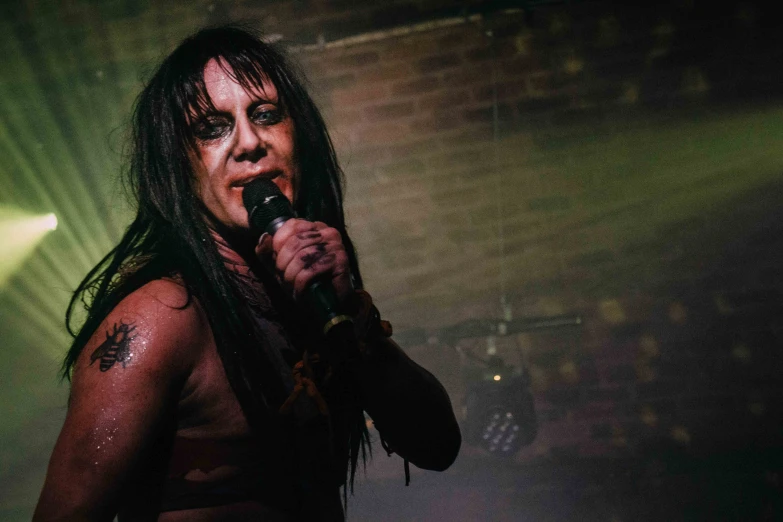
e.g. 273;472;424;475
74;279;211;381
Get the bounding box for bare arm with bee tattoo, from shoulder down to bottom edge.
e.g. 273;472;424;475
34;281;209;521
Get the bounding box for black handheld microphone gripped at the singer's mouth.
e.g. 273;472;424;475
242;178;353;350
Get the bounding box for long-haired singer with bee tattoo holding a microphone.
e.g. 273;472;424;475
34;27;461;521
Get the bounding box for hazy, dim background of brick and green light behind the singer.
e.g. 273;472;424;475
0;0;783;521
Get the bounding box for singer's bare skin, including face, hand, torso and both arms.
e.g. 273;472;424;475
34;60;460;522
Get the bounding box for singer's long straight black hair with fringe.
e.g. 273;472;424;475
63;27;368;492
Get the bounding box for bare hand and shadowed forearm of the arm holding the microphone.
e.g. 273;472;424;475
256;219;462;471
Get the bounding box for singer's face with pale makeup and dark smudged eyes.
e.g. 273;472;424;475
190;60;299;230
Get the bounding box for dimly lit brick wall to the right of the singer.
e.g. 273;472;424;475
280;2;783;460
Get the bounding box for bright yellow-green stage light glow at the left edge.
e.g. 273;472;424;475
0;207;57;288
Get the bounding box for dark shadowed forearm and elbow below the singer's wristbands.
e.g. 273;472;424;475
356;338;462;471
